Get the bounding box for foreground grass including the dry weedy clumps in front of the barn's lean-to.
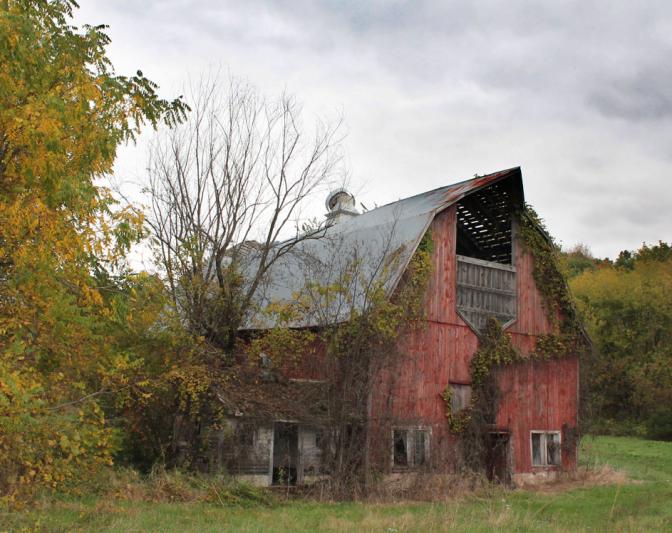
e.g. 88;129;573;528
0;437;672;533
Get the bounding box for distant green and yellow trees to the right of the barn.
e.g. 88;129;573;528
562;242;672;439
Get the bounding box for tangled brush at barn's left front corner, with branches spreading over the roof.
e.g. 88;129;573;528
257;230;433;498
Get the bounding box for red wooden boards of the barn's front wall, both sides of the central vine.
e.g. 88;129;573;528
370;206;578;472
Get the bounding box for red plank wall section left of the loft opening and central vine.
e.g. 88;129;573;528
371;206;478;471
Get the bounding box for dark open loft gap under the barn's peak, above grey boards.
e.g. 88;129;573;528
457;179;519;265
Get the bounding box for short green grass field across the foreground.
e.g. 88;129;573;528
0;437;672;533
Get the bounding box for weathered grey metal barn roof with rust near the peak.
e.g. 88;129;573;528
241;167;523;329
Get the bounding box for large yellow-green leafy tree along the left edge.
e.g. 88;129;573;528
0;0;187;500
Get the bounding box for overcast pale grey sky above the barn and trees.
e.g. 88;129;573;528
75;0;672;257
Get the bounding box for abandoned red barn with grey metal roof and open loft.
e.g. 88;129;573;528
211;168;579;485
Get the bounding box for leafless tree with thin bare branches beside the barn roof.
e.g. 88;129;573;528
146;77;341;348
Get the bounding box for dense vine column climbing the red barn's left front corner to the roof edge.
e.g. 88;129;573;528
300;232;433;497
